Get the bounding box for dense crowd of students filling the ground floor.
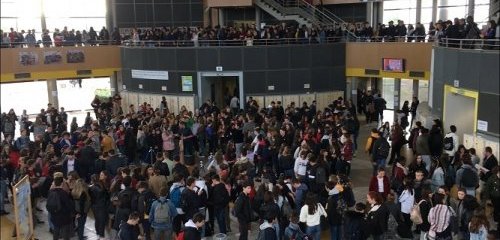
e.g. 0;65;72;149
0;88;500;240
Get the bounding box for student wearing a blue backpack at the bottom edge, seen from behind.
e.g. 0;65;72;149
149;187;177;240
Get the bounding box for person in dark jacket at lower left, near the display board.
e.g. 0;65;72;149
46;176;75;240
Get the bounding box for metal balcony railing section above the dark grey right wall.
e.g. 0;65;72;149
436;38;500;50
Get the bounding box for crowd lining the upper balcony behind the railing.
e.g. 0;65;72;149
0;16;499;47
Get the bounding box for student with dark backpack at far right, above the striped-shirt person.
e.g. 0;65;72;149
455;154;479;197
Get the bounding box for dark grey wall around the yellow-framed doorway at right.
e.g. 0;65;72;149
431;47;500;135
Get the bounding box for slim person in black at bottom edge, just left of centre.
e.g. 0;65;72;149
234;182;252;240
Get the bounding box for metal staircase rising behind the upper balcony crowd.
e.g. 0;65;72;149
254;0;354;34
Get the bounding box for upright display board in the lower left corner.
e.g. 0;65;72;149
13;176;33;240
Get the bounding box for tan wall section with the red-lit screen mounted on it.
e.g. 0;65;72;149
346;42;432;80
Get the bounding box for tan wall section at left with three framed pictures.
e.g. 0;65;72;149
0;46;121;83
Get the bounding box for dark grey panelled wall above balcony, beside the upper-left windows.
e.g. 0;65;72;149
115;0;203;28
